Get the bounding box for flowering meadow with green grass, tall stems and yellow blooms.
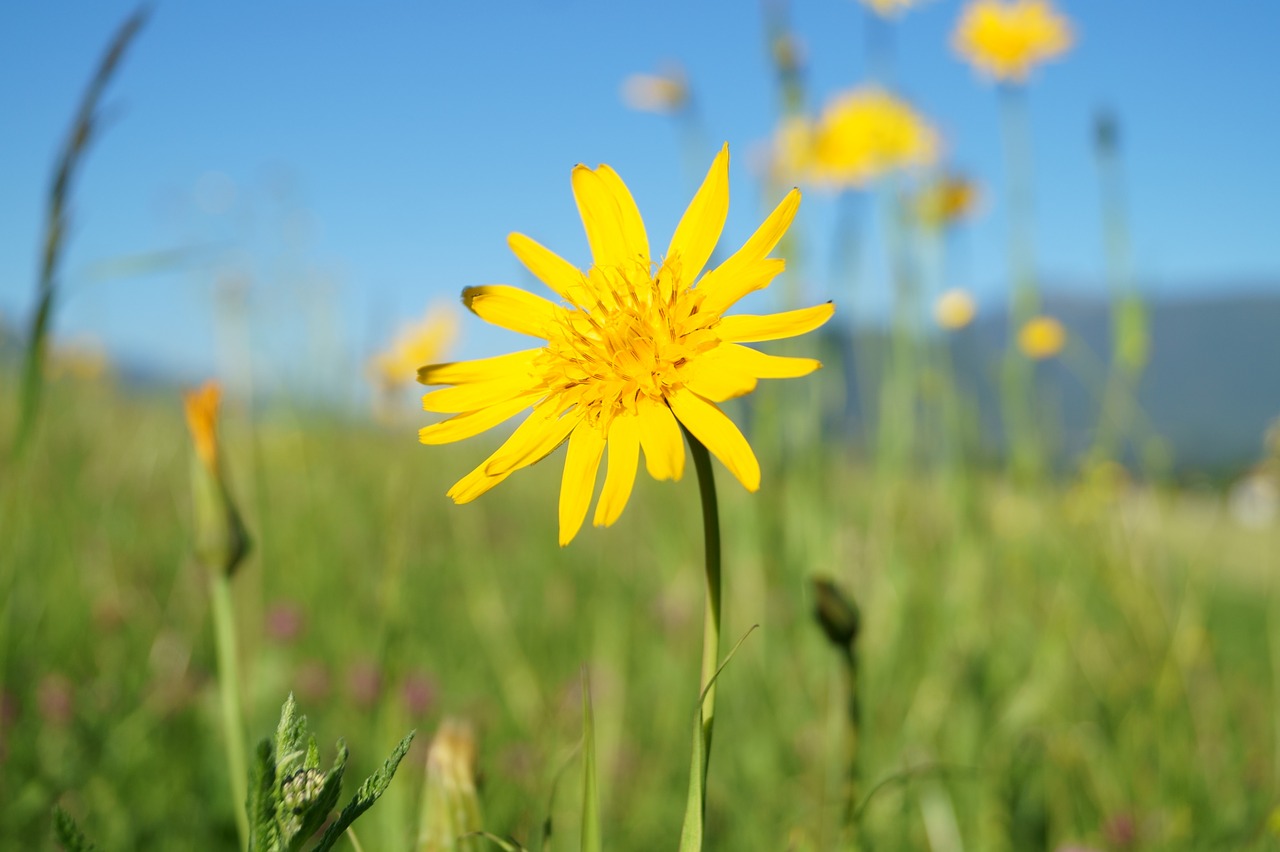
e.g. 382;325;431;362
0;0;1280;852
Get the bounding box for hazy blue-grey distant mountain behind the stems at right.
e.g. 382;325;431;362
841;284;1280;471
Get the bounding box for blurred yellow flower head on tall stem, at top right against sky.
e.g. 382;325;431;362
952;0;1073;82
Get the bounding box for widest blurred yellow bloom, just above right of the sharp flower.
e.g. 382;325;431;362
774;87;938;189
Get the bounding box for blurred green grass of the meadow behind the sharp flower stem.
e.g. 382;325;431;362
0;376;1280;852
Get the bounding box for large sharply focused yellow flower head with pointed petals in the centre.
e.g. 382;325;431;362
419;145;835;545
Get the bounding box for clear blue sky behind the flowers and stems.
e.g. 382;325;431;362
0;0;1280;388
